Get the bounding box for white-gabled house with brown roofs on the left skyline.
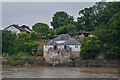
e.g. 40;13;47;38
4;24;32;35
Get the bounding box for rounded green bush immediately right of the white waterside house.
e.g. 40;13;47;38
80;37;100;60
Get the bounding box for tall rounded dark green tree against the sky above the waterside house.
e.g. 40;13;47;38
51;11;74;29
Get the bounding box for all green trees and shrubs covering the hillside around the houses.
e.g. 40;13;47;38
2;2;120;65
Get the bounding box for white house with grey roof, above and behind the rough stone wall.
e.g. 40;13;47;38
43;34;81;60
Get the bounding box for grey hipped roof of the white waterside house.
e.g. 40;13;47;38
46;34;80;45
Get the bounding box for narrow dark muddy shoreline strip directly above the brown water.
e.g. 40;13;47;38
2;61;120;68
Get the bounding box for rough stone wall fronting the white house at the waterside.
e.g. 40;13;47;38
46;48;72;64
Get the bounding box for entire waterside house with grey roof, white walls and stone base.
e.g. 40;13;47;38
43;34;81;62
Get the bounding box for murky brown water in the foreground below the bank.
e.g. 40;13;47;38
2;66;118;78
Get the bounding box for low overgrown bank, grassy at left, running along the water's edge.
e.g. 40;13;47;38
2;57;120;68
